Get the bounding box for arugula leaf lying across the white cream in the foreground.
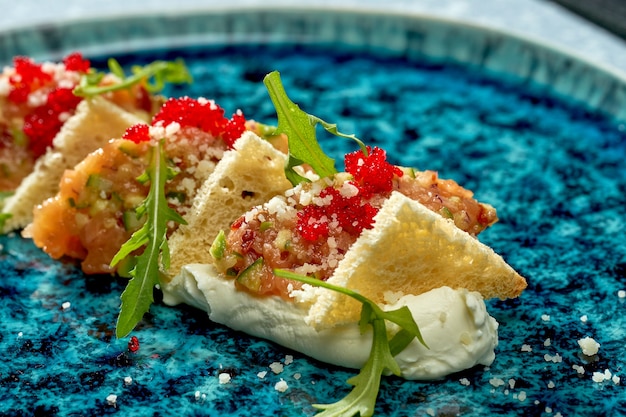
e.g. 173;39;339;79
274;269;428;417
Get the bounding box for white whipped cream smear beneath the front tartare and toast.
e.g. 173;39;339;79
162;264;498;380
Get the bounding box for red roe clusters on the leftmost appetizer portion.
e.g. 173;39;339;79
8;53;91;158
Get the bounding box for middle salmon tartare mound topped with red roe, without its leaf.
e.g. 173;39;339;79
23;97;245;274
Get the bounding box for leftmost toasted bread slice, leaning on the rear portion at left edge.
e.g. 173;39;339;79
2;97;144;233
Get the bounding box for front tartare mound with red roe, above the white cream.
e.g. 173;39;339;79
216;148;497;299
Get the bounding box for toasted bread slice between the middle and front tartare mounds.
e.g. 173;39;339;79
168;132;292;276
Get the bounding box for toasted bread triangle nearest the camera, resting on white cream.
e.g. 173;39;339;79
307;192;526;328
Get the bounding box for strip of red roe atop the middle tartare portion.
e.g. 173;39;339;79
152;97;246;148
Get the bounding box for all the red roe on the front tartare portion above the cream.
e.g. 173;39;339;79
296;147;403;241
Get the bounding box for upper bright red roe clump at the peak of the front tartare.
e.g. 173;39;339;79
344;146;403;199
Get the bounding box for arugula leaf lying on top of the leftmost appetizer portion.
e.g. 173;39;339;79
74;58;192;97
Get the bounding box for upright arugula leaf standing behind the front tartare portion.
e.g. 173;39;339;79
263;71;367;185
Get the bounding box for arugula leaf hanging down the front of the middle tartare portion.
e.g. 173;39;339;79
111;139;186;338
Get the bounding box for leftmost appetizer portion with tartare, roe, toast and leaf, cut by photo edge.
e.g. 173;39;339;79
0;53;189;233
